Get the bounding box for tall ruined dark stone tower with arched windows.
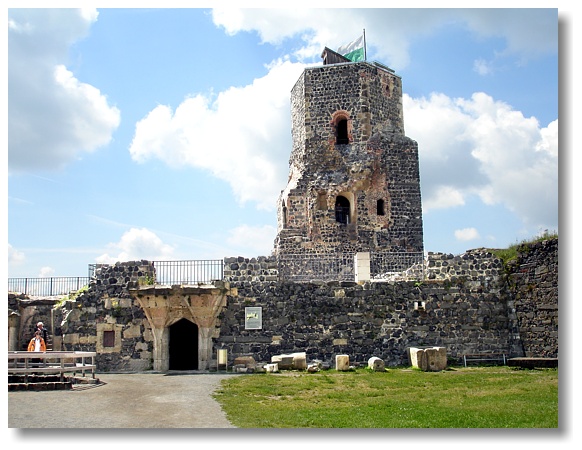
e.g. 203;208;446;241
274;48;424;264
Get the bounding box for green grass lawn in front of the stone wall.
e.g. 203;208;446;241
215;366;558;428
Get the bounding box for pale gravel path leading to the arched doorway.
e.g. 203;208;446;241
8;372;240;428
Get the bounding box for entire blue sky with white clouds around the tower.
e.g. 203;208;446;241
7;5;559;277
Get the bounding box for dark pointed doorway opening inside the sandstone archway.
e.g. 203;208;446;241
169;319;198;370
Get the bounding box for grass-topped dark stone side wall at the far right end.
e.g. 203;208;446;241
508;239;558;358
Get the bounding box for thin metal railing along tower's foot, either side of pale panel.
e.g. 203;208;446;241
278;252;424;281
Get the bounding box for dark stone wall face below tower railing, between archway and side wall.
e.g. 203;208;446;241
216;274;521;366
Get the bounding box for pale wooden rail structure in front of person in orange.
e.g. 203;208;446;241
8;351;97;378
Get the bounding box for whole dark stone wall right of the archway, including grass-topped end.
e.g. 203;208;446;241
216;244;558;366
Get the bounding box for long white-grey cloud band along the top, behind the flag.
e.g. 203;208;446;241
212;6;558;70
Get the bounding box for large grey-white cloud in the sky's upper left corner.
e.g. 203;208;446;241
8;9;120;172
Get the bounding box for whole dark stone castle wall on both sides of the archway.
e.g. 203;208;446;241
9;239;558;372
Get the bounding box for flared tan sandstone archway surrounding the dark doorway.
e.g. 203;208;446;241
129;281;236;372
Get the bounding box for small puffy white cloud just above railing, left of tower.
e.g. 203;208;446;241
96;228;174;264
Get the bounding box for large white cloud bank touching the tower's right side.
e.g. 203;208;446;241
403;93;558;228
